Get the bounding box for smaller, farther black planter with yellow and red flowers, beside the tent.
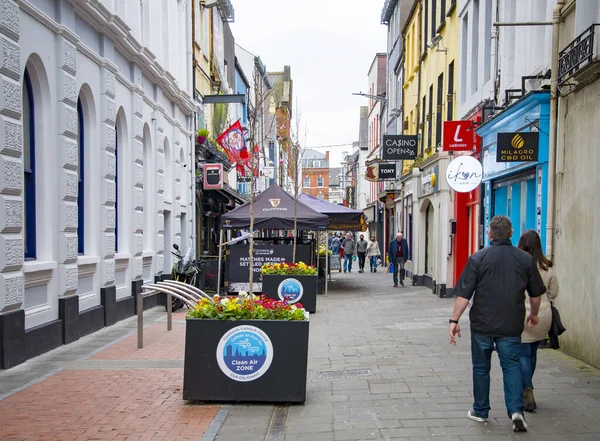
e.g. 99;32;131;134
260;262;317;312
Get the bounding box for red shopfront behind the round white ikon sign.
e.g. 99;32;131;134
453;110;483;283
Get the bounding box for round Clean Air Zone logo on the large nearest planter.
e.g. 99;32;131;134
217;326;273;382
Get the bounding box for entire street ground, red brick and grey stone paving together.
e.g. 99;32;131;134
0;269;600;441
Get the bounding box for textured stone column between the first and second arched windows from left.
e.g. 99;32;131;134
56;37;79;344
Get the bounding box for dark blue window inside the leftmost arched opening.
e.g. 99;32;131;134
23;68;37;260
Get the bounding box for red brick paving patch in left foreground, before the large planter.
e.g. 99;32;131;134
0;369;219;441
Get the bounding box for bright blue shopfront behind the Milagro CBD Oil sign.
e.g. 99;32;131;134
477;91;550;249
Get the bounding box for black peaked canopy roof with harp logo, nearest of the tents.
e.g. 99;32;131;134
221;184;329;230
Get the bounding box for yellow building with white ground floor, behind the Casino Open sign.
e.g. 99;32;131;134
396;0;459;297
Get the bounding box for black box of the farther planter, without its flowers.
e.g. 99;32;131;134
262;274;317;312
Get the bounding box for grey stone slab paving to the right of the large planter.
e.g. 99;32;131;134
210;272;600;441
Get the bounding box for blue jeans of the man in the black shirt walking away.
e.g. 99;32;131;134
471;333;524;418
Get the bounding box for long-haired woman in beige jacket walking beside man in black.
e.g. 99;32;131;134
518;230;558;412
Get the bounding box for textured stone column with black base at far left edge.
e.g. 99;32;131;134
0;0;26;369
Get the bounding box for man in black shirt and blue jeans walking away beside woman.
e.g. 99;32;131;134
450;216;546;432
